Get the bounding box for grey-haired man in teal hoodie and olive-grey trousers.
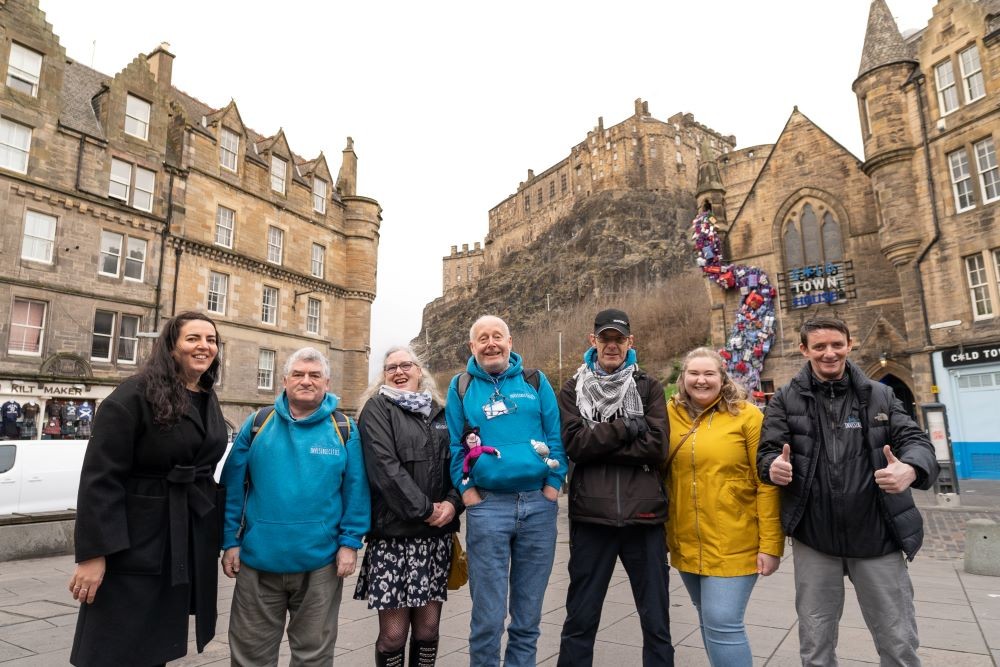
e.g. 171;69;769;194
221;347;371;665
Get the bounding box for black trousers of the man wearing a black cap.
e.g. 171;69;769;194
559;521;674;667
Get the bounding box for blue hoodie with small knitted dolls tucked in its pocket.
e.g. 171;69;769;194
445;352;567;492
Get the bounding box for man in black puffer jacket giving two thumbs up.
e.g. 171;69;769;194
757;317;938;667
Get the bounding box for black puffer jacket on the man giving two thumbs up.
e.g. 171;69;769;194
757;361;938;560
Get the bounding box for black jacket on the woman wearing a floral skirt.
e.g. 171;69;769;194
358;395;464;537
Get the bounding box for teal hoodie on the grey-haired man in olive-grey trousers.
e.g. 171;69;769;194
221;392;371;573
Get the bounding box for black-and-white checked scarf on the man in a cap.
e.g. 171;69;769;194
576;348;643;428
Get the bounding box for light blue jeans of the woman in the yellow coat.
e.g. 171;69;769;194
681;572;757;667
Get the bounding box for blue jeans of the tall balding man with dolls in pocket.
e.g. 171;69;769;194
465;489;559;667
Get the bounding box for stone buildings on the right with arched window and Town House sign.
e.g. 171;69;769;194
699;0;1000;478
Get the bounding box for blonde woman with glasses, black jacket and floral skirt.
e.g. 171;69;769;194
354;346;463;667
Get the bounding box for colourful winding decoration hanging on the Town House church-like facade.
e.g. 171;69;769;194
691;208;778;402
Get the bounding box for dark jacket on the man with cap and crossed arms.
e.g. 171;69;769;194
559;368;669;527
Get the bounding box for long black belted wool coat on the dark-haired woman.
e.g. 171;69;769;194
70;377;227;667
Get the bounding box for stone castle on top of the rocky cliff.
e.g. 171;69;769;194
483;99;736;273
